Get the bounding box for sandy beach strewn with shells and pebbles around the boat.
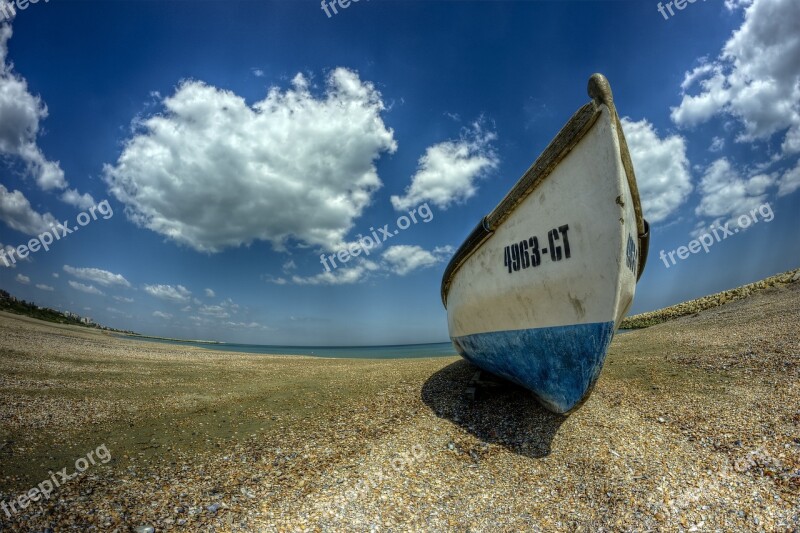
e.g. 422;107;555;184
0;271;800;532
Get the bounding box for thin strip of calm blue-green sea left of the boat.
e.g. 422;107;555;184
122;336;458;359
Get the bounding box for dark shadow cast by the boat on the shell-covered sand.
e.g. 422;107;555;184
422;359;567;458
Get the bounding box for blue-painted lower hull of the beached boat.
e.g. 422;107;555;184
453;322;615;413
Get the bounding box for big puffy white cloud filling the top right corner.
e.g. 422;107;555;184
672;0;800;154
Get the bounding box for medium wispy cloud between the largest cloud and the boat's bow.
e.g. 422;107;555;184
391;122;498;211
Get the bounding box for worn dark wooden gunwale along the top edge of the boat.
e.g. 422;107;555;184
441;74;649;308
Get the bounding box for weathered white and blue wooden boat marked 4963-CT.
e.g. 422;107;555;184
442;74;649;413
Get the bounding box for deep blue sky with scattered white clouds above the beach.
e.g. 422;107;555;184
0;0;800;346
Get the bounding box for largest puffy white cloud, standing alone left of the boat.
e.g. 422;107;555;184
105;68;396;252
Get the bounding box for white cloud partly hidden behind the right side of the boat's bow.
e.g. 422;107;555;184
621;117;692;223
